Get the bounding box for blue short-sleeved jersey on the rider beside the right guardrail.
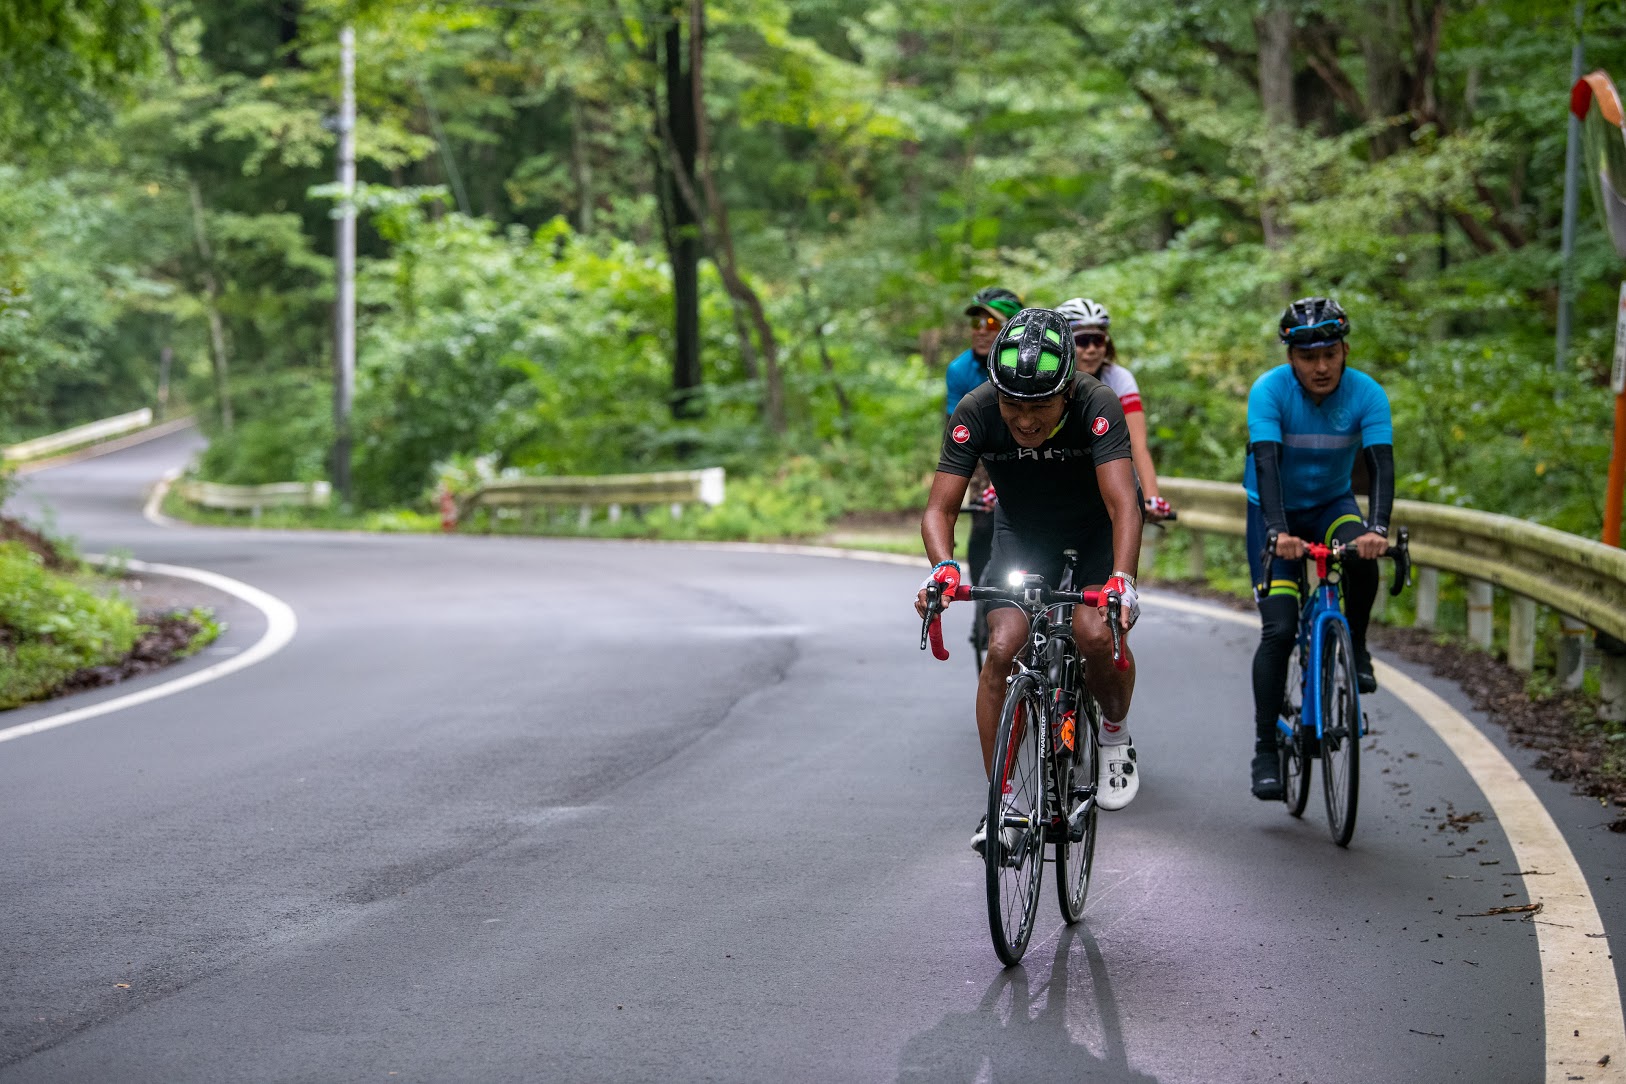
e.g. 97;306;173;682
1242;364;1395;510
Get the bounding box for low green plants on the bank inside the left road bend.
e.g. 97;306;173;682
0;543;140;710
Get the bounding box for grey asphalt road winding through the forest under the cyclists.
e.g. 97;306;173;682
0;434;1626;1084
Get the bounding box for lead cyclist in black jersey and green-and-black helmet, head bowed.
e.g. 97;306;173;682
915;309;1141;847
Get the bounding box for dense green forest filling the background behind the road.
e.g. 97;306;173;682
0;0;1626;535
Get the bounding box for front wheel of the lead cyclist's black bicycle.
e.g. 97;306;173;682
982;674;1046;965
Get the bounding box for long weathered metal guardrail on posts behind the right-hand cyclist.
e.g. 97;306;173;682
1158;478;1626;713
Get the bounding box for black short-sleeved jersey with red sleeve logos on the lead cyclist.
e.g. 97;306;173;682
937;372;1130;535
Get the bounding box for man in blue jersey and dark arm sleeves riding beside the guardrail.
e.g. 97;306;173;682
1244;297;1395;801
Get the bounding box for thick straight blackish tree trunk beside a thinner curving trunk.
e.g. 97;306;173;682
657;20;701;419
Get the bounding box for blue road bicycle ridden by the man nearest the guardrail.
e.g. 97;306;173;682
1265;527;1411;847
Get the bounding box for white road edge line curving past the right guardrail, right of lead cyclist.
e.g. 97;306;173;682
1141;593;1626;1084
